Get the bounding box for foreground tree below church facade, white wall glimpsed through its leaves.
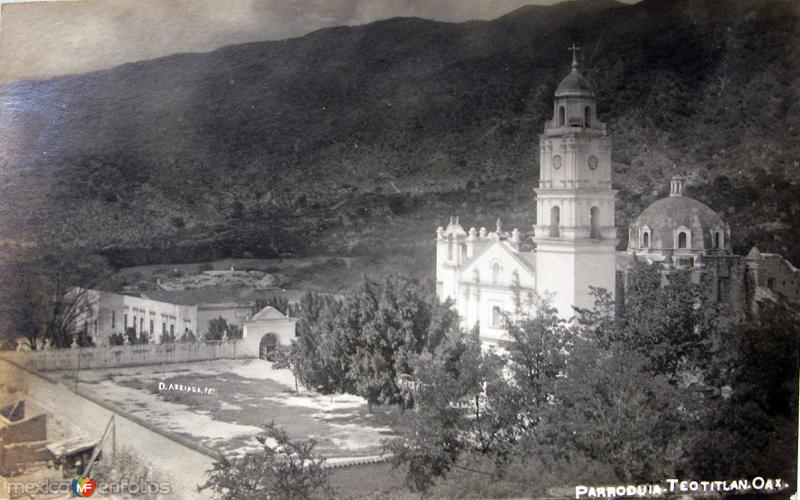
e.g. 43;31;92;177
386;329;525;492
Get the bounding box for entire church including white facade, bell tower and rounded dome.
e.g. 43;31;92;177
436;46;800;344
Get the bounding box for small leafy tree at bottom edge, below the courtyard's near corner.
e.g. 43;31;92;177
198;422;332;500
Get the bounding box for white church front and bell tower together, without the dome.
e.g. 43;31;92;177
436;49;616;342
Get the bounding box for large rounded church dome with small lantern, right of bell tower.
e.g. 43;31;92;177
628;178;729;253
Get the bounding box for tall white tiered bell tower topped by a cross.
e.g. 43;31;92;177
535;44;616;318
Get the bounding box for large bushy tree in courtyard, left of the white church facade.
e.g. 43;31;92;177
292;277;458;409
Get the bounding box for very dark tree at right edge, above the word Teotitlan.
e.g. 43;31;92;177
692;301;800;477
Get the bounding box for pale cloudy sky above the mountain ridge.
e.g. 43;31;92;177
0;0;632;82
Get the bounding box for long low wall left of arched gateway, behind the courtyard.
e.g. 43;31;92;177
0;339;252;371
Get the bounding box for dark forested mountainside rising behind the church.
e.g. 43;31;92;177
0;0;800;267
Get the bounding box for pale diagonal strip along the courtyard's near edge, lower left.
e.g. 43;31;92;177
0;359;213;499
